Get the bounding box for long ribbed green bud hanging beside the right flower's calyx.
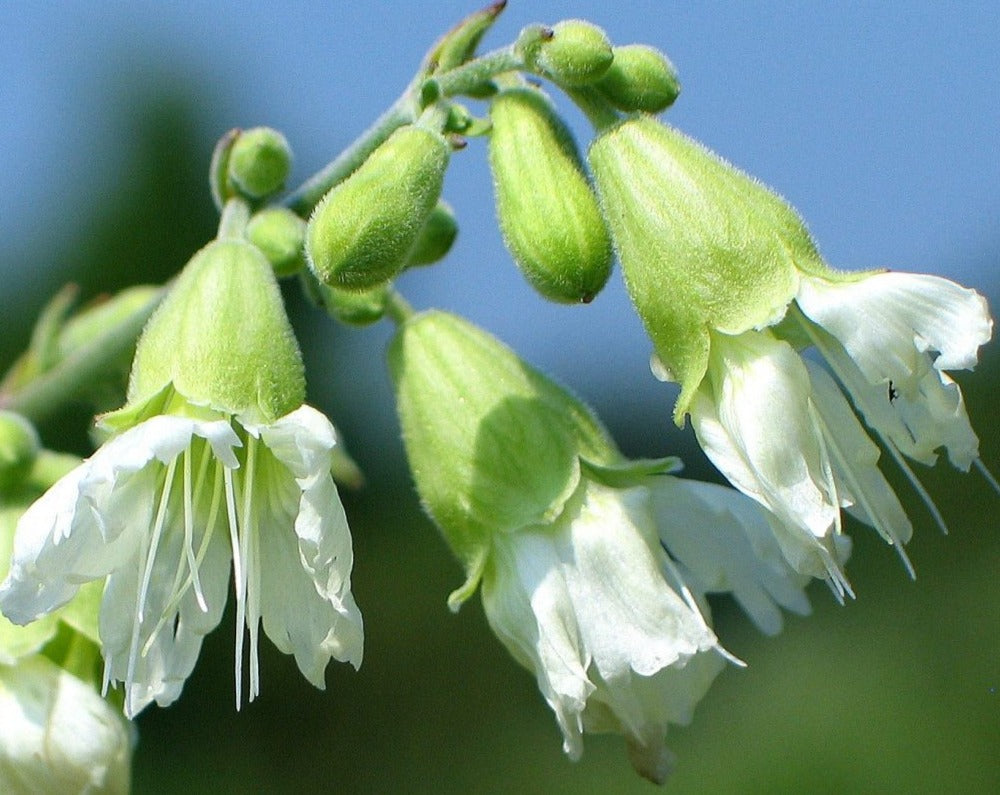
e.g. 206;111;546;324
490;88;611;303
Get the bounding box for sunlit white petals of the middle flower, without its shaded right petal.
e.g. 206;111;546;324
482;480;723;782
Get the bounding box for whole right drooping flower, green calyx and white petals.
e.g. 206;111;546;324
590;116;992;596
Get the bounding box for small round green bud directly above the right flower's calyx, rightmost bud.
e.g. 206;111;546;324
594;44;681;113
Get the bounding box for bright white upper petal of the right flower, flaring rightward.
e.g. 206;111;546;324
796;271;993;385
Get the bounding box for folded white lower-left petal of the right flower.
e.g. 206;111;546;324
690;332;840;579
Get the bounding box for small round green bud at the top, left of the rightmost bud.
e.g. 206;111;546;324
515;19;614;86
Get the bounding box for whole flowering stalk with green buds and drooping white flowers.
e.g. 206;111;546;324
0;3;997;790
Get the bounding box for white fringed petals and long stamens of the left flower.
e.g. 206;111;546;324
0;406;363;716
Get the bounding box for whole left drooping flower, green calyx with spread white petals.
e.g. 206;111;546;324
0;239;363;716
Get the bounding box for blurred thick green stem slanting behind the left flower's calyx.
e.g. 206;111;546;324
0;289;166;423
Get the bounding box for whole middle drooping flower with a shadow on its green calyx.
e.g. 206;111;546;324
389;312;808;781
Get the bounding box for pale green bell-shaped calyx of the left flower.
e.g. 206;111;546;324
118;239;305;428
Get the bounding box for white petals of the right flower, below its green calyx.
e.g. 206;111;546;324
690;273;992;594
